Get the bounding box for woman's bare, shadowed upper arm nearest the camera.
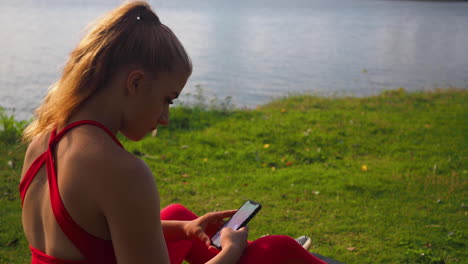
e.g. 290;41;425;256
98;155;169;264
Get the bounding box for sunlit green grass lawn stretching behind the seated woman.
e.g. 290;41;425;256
0;89;468;263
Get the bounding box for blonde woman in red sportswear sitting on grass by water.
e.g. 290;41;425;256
20;2;323;264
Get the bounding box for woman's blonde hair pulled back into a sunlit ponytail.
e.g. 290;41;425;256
23;1;192;143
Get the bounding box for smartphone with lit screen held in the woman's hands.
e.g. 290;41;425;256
211;200;262;249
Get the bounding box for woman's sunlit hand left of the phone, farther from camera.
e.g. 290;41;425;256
184;210;237;247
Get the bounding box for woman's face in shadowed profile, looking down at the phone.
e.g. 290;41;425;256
121;69;188;141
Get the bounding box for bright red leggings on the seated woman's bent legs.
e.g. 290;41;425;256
161;204;326;264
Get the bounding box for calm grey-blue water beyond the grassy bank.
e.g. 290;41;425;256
0;0;468;119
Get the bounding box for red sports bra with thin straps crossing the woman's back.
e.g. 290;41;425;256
19;120;123;264
